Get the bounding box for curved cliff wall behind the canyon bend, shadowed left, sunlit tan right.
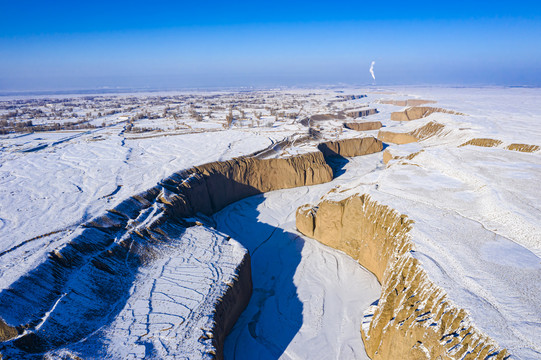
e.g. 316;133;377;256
159;152;332;217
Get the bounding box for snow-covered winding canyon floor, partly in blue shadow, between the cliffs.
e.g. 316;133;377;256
214;154;381;359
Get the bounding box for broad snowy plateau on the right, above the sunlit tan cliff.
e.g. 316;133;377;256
312;88;541;359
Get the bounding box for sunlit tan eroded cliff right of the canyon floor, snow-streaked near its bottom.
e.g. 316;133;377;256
296;195;508;360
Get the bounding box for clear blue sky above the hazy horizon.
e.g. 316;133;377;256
0;0;541;90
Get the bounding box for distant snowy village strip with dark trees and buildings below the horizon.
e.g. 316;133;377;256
0;91;374;135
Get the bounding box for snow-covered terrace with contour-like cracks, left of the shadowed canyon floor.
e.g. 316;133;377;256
49;226;246;359
